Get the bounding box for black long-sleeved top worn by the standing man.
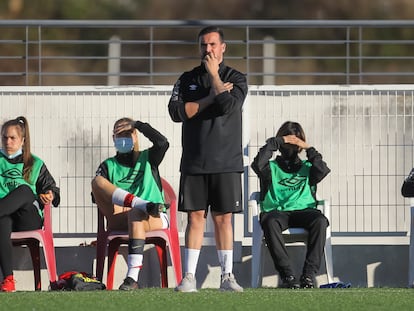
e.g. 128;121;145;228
168;63;247;175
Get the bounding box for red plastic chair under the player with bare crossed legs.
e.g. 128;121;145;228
96;179;182;290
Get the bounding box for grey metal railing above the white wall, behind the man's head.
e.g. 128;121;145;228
0;20;414;86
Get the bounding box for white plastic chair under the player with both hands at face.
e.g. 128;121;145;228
249;192;333;288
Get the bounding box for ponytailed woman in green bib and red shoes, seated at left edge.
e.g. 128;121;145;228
0;117;60;292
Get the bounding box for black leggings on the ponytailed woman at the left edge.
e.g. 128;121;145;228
0;185;43;277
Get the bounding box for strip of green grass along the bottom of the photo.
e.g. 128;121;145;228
0;288;414;311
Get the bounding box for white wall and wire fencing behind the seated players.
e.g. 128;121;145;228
0;85;414;245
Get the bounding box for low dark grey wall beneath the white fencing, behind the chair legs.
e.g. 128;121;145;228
9;245;408;291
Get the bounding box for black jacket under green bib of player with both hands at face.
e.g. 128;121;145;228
251;137;331;200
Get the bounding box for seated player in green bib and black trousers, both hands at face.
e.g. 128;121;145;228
251;121;330;288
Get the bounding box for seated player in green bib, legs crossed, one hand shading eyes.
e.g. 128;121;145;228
92;118;169;290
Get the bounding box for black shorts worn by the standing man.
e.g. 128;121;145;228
178;173;243;213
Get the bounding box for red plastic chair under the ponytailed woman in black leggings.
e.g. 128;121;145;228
11;205;57;291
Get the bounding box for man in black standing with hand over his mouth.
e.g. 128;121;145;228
168;26;247;292
